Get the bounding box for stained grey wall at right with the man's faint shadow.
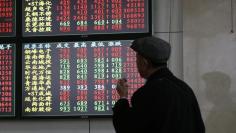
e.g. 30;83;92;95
183;0;236;133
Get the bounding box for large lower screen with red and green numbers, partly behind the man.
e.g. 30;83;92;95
22;40;144;116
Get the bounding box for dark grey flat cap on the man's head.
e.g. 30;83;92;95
130;36;171;64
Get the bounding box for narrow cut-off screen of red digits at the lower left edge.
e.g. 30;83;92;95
0;44;15;117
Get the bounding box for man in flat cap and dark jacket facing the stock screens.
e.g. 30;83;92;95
113;37;205;133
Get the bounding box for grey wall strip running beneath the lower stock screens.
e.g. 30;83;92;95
0;119;115;133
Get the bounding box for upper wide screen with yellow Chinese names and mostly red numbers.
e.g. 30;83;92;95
22;0;149;36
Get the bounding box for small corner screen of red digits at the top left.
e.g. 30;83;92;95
0;0;15;36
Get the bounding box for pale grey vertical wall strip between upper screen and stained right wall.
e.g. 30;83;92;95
153;0;183;79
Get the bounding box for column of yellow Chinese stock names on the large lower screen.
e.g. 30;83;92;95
23;44;53;112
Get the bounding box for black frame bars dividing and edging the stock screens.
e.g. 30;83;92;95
0;0;152;119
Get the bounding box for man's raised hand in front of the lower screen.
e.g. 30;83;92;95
116;79;128;98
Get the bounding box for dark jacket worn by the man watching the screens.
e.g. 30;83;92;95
113;68;205;133
